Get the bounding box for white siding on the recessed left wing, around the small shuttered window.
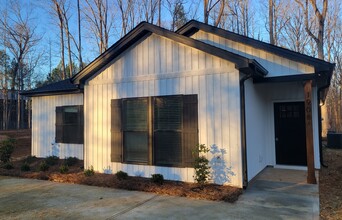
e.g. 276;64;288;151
32;94;83;159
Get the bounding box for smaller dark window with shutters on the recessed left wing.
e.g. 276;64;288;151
56;105;83;144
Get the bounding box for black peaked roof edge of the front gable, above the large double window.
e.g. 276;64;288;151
71;22;268;84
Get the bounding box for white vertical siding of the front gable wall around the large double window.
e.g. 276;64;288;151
84;34;242;187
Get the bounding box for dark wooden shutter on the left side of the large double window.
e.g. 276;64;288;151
111;99;122;162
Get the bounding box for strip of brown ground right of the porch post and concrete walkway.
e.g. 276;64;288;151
319;148;342;220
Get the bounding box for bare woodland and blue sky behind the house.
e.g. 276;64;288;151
0;0;342;132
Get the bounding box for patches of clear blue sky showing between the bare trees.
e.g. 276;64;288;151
0;0;267;82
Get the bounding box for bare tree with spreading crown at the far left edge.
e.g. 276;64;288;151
0;1;41;129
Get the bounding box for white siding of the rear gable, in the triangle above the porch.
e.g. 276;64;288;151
191;30;315;77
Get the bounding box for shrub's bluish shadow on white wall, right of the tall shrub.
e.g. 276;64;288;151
209;144;235;184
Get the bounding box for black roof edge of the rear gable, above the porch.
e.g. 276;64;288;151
176;20;335;74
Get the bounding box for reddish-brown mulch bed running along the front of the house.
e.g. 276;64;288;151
0;130;242;202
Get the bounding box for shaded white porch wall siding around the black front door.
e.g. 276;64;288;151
245;80;320;180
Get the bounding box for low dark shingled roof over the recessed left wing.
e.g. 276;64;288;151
20;79;82;96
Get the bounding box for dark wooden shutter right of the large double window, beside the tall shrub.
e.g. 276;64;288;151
183;95;198;167
